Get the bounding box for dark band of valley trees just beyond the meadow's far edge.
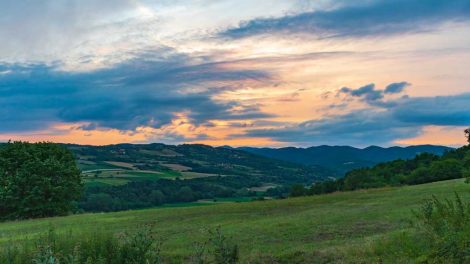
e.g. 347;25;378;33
79;176;259;212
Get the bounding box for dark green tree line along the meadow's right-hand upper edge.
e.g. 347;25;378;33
306;142;470;194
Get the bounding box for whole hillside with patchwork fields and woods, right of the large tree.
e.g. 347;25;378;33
65;144;333;212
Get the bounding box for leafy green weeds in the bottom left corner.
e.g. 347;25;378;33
0;227;162;264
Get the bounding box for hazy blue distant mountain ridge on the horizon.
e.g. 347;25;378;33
237;145;452;176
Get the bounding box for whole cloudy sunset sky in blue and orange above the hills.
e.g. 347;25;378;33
0;0;470;147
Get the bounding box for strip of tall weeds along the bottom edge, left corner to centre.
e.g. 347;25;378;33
0;226;239;264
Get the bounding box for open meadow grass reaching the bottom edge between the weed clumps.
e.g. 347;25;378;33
0;179;470;263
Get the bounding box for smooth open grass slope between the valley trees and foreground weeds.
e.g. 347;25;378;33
0;180;470;257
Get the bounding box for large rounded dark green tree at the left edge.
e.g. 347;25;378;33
0;142;83;220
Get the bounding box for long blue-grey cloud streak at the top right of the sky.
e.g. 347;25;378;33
220;0;470;38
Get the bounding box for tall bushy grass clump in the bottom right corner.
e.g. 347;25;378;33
371;194;470;264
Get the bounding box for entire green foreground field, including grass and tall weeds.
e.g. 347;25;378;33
0;179;470;263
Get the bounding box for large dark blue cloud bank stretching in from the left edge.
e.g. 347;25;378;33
0;51;270;132
